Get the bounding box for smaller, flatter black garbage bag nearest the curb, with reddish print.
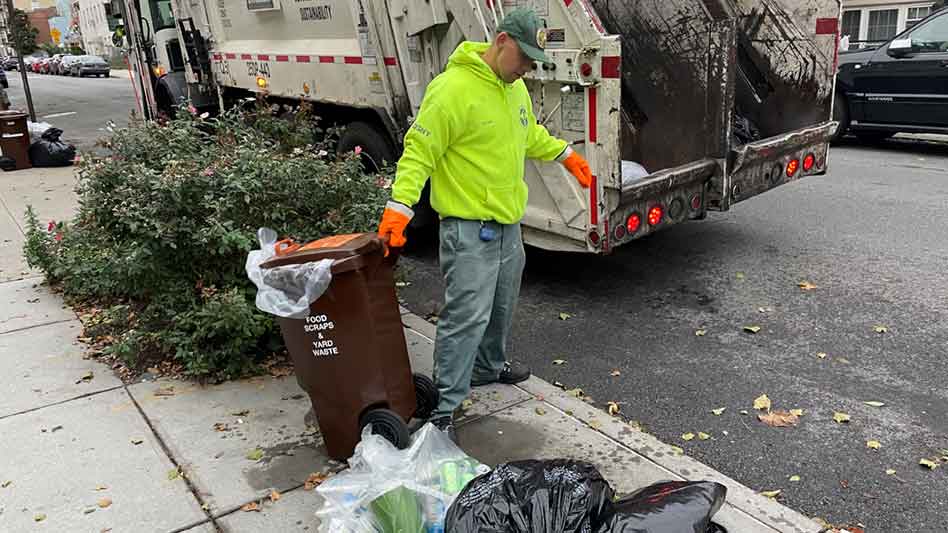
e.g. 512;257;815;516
599;481;727;533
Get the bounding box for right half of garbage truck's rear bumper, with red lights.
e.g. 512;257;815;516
724;122;837;207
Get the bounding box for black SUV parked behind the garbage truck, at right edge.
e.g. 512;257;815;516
833;9;948;140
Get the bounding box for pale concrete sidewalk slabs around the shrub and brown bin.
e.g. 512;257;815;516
0;165;820;533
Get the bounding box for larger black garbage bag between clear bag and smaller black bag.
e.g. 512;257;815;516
445;459;613;533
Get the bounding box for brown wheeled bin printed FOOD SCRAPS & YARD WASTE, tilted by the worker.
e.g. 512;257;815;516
260;233;438;461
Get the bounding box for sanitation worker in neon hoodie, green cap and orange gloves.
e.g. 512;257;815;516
378;9;592;442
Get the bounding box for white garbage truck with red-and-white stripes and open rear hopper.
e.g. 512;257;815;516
112;0;841;254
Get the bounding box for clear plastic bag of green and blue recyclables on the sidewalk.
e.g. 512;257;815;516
316;423;490;533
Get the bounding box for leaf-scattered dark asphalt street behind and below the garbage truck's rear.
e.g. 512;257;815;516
399;139;948;533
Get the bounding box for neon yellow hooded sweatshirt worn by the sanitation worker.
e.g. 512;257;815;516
392;42;567;224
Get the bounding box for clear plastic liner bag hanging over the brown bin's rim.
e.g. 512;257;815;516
245;228;333;318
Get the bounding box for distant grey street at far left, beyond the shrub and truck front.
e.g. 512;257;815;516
7;71;136;149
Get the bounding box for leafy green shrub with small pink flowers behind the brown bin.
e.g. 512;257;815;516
24;103;390;379
